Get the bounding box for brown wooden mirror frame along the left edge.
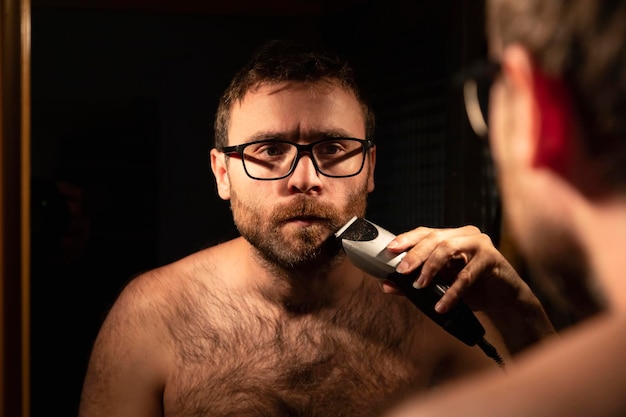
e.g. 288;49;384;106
0;0;31;417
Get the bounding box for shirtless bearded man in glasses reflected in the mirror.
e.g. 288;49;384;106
80;42;551;417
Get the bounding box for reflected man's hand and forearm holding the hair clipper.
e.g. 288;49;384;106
383;226;556;354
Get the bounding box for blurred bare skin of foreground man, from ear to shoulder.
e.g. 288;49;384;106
378;34;626;417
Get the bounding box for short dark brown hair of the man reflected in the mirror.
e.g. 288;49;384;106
215;39;374;149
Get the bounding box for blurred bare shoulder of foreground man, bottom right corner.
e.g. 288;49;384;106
385;316;626;417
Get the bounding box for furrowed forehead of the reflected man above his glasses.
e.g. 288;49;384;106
228;81;365;144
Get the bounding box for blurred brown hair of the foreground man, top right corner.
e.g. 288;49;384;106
487;0;626;188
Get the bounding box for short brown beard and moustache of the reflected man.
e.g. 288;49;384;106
231;185;368;274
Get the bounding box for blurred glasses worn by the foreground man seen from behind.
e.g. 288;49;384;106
459;61;500;137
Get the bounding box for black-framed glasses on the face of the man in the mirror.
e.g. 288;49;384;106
221;138;374;180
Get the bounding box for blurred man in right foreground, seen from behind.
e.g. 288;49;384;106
380;0;626;417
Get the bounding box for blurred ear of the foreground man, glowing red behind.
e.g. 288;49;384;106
502;44;571;174
